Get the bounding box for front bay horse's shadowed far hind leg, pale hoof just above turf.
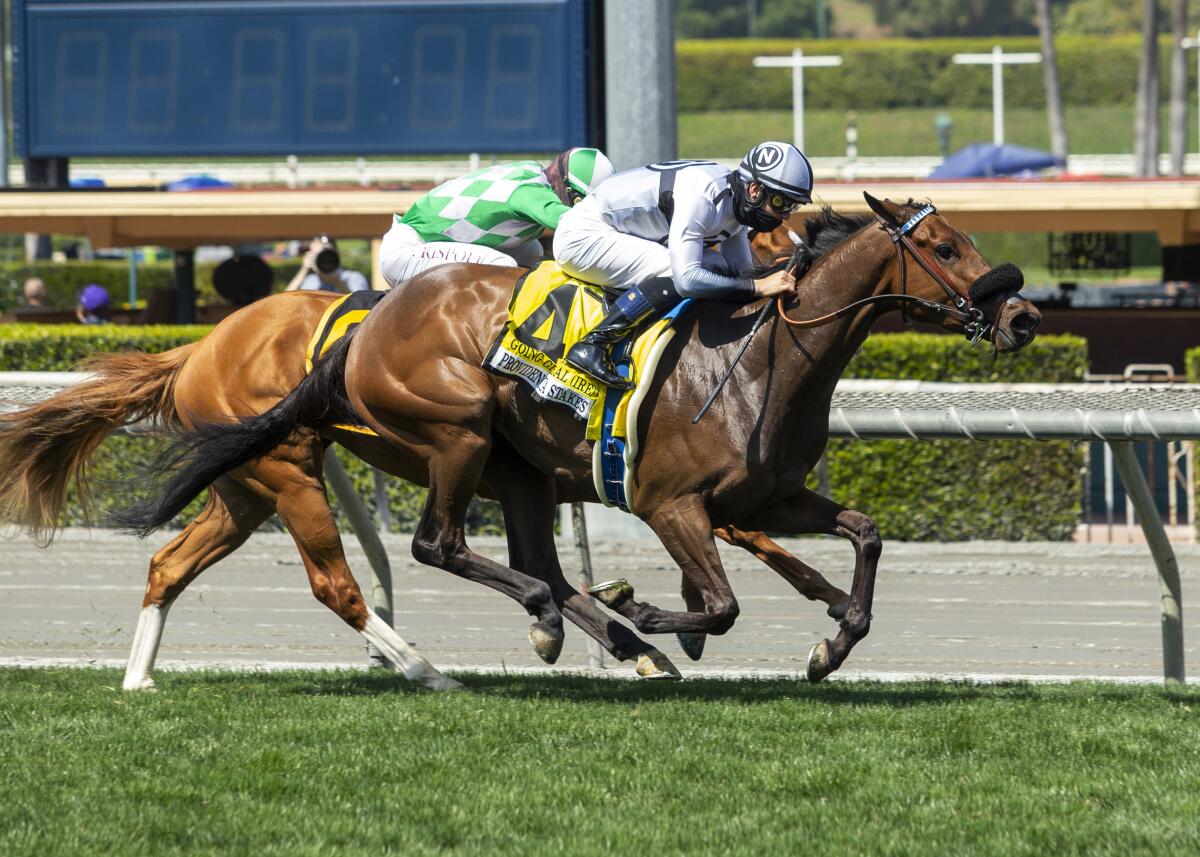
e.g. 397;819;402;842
485;449;679;678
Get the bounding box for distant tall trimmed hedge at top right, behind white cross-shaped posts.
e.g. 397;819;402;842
676;35;1176;113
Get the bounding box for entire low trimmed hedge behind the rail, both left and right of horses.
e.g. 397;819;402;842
0;324;1089;541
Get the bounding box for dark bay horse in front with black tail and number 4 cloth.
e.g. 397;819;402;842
77;194;1040;681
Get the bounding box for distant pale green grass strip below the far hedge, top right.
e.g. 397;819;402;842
679;106;1196;157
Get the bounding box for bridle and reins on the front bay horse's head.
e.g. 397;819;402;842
776;203;992;344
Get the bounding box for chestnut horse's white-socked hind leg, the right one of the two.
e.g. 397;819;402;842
267;443;462;690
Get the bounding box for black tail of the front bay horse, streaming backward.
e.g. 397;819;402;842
110;332;359;538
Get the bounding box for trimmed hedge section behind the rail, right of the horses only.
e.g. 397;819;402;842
830;334;1087;541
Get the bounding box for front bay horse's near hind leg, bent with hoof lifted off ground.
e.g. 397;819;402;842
413;434;563;664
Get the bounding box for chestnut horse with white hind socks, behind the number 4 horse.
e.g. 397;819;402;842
0;222;825;690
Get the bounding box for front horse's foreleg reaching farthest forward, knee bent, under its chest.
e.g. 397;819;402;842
743;490;883;682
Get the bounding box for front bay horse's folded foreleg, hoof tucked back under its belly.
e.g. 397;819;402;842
593;497;738;640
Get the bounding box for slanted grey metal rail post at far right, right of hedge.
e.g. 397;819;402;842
1109;442;1184;684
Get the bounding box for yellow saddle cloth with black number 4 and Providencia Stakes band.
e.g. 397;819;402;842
484;262;691;511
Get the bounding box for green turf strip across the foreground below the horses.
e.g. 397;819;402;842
0;670;1200;857
